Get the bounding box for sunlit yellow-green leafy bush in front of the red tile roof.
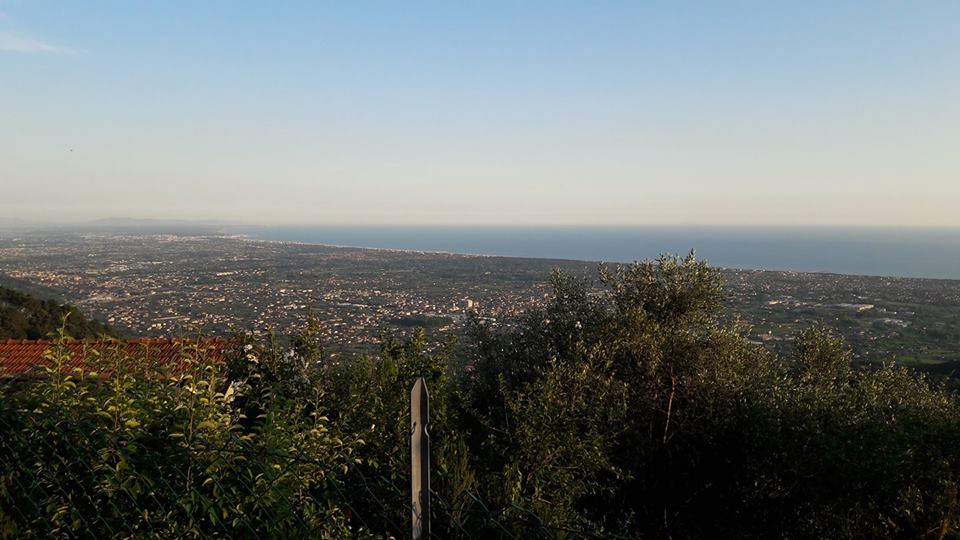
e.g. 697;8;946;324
0;326;359;538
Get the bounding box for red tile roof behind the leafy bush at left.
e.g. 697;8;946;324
0;338;236;376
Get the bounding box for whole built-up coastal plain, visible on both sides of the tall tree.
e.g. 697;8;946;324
0;231;960;366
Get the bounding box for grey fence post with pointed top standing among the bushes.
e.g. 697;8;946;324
410;377;430;540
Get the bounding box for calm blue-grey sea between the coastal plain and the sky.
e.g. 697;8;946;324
233;226;960;279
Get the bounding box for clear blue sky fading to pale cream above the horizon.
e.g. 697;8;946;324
0;0;960;227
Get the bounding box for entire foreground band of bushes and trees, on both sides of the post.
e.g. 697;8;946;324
0;257;960;538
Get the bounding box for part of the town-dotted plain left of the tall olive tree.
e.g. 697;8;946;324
0;233;564;354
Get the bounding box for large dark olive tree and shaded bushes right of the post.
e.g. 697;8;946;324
461;256;960;538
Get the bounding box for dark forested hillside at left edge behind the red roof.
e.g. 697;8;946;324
0;287;117;339
